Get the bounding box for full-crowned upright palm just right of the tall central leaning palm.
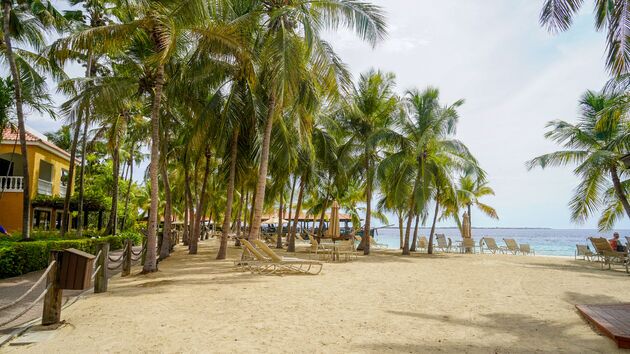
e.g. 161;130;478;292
340;70;398;255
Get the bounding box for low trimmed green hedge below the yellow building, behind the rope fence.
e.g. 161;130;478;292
0;233;142;279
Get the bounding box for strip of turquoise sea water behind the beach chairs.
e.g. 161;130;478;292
375;228;630;256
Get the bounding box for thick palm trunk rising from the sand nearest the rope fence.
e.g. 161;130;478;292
142;64;164;273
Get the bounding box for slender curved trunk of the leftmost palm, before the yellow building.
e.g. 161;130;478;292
3;1;31;240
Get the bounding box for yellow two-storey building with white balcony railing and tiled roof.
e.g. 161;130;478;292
0;128;70;231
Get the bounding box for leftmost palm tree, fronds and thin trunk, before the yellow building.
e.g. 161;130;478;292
2;0;64;239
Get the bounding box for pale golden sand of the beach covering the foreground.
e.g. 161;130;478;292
0;240;630;353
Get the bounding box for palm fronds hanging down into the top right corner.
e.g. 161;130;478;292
540;0;630;76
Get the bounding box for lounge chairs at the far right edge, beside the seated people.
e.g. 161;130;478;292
575;237;630;273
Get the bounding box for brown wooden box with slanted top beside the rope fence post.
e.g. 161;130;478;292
59;248;96;290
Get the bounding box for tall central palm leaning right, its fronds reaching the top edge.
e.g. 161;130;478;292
249;0;385;239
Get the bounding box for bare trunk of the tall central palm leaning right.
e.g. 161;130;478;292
249;93;276;240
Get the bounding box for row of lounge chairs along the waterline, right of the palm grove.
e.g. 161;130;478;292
417;234;536;255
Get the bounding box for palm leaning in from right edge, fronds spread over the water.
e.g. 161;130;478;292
527;91;630;222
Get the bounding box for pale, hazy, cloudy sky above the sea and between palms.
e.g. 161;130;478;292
27;0;630;229
